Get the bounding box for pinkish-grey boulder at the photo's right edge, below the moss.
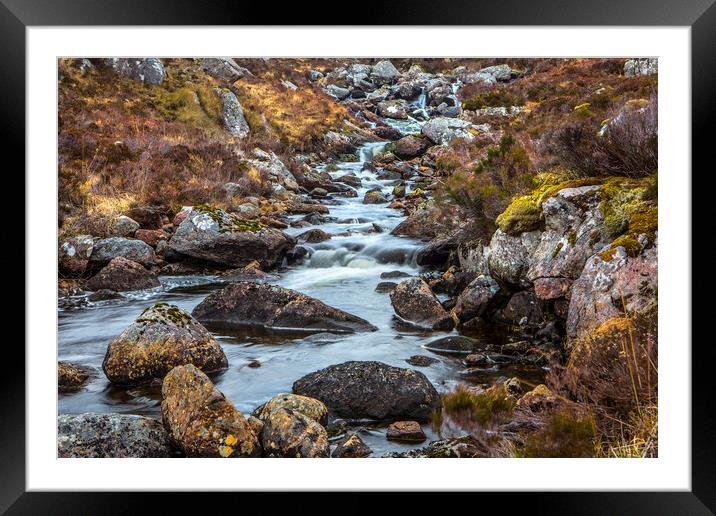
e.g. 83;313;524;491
566;241;659;340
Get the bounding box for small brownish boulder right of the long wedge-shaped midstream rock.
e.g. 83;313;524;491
390;278;455;330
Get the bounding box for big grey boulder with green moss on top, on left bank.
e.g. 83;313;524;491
167;206;294;269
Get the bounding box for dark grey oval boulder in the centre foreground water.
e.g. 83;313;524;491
293;362;440;421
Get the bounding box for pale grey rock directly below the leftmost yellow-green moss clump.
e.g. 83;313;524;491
487;229;540;287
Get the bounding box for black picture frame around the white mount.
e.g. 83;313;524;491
7;0;716;514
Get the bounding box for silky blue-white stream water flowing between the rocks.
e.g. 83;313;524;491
59;138;532;456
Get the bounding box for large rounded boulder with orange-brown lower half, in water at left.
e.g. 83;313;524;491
102;303;228;385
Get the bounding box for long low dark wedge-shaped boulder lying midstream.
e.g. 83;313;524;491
192;282;376;333
